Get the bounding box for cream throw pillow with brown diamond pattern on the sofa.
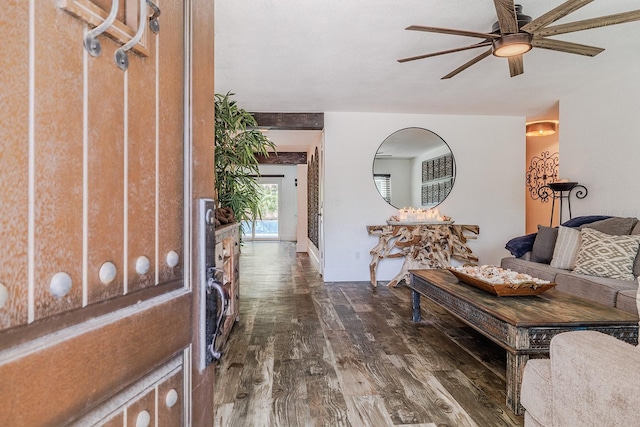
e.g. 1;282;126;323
573;228;640;280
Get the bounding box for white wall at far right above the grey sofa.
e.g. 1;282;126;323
560;70;640;217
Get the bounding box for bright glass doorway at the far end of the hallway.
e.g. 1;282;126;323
242;177;282;241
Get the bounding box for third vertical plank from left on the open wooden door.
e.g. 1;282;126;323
86;35;125;304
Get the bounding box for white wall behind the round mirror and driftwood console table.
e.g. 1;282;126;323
324;112;525;282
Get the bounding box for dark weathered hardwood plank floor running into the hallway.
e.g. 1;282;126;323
214;242;523;427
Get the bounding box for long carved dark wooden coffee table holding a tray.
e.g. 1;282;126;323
409;269;638;415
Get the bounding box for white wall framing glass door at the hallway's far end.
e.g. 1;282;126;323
260;165;298;242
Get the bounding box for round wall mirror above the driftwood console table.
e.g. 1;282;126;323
373;127;456;209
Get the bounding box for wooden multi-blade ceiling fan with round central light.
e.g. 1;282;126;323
398;0;640;79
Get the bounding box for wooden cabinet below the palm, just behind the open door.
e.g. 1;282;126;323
216;223;240;346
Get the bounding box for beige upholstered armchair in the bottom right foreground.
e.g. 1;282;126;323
520;280;640;427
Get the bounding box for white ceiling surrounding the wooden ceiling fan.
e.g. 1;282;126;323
215;0;640;119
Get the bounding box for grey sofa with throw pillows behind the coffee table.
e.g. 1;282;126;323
500;216;640;314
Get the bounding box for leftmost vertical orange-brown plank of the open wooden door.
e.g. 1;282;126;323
0;1;29;330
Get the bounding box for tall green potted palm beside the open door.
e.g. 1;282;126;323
214;92;276;229
